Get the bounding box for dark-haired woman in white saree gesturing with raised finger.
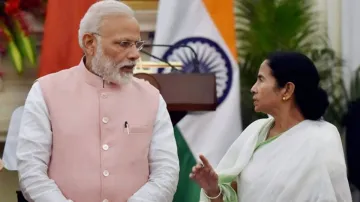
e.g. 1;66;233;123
190;52;351;202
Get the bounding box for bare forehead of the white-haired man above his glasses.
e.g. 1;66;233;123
99;14;140;41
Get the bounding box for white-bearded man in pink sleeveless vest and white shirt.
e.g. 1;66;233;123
17;0;179;202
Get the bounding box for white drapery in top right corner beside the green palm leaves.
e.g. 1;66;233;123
313;0;360;90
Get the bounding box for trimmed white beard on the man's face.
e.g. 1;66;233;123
91;44;136;85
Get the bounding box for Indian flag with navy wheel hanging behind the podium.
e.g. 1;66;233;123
152;0;242;202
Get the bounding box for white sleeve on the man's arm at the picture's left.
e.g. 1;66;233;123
16;82;71;202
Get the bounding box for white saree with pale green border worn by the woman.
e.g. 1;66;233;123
200;118;352;202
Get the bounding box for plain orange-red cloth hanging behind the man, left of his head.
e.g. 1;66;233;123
39;0;96;77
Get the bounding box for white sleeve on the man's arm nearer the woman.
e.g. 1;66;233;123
128;95;180;202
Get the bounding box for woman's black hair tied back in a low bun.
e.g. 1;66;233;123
267;51;329;120
